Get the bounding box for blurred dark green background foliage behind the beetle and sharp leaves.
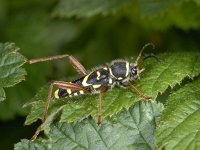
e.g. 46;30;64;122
0;0;200;150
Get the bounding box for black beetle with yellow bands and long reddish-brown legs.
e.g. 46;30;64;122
28;43;155;140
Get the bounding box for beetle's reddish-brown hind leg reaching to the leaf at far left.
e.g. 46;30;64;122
28;54;87;75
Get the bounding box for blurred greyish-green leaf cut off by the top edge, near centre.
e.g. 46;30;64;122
54;0;131;17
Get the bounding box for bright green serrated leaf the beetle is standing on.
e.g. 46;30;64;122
25;52;200;128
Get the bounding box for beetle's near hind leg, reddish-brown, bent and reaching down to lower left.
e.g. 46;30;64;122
31;81;90;141
